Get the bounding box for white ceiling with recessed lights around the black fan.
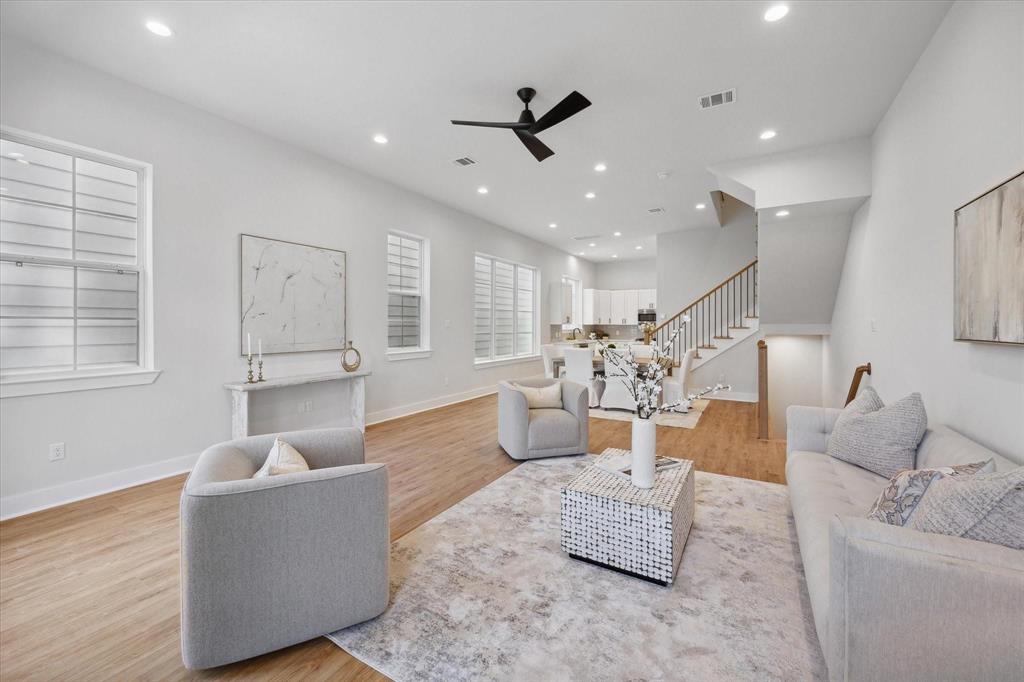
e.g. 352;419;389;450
0;0;949;261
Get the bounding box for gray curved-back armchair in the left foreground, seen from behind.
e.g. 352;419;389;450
181;428;390;669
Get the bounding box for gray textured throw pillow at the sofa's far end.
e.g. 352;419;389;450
826;386;928;478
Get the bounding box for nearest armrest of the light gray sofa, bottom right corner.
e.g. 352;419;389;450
821;516;1024;681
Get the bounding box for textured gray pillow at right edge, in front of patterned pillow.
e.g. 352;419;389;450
906;467;1024;550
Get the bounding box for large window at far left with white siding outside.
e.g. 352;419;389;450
0;131;155;394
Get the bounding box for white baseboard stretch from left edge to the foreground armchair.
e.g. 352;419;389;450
0;453;199;520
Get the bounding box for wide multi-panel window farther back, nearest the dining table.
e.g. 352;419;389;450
473;254;539;364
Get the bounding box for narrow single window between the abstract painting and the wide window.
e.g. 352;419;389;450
387;231;430;354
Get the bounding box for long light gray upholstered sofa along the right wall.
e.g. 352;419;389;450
785;406;1024;680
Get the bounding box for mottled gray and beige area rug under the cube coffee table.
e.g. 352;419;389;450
328;456;826;682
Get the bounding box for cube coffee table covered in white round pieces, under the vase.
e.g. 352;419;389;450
561;447;694;586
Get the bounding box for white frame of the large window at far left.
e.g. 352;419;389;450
0;126;161;398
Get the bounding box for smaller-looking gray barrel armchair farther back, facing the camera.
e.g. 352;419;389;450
498;379;590;460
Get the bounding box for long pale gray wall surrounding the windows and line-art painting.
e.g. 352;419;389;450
0;38;594;501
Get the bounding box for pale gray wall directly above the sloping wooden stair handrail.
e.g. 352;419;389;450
656;202;757;319
